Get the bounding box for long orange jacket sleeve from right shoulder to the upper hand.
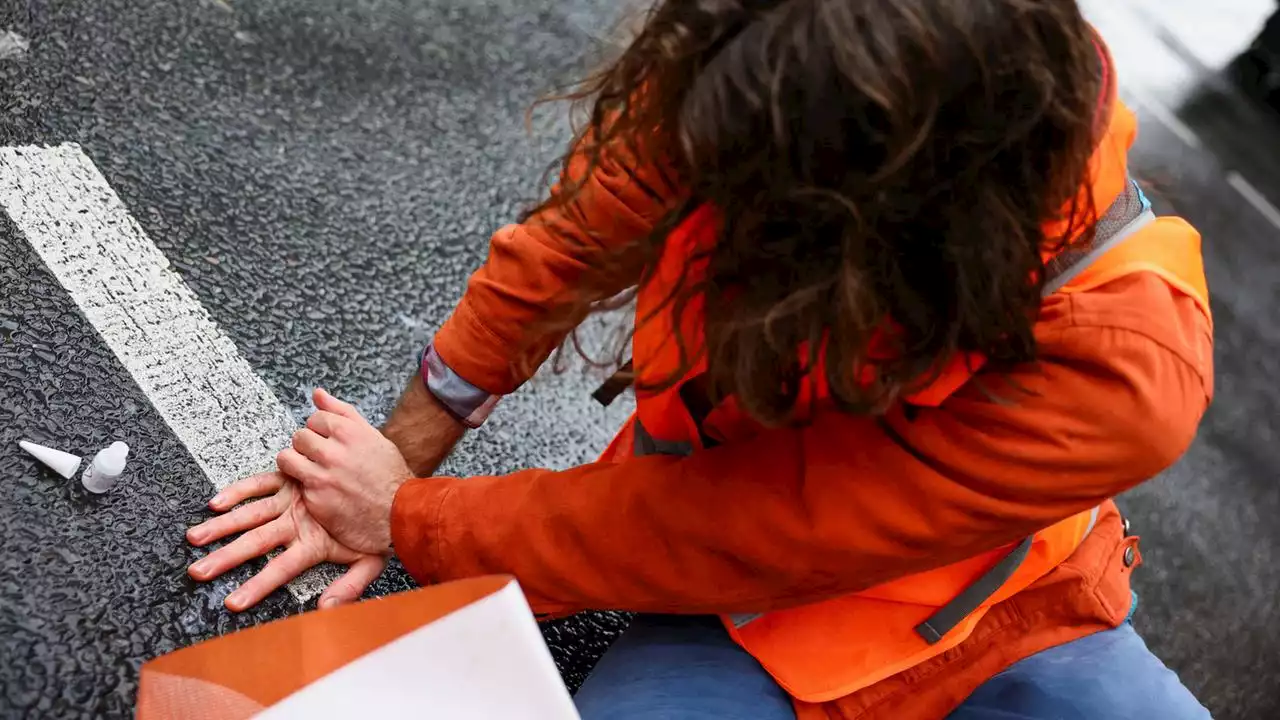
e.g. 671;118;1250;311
392;275;1212;614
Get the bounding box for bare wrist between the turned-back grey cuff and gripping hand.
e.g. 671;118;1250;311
383;374;466;478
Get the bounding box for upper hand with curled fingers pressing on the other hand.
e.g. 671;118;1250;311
285;389;412;555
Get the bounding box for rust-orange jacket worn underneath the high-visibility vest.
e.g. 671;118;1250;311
392;96;1212;717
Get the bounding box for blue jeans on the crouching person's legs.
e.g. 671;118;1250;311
575;615;1210;720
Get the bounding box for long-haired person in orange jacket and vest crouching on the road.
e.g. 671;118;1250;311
188;0;1212;720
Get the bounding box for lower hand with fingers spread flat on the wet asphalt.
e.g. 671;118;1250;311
187;473;387;612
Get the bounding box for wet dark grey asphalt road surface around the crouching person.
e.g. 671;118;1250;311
0;0;1280;719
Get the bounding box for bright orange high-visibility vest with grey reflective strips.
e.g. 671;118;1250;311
613;90;1210;702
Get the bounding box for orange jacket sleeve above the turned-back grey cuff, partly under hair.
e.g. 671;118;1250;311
434;134;677;395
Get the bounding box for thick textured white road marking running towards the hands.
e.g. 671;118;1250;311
0;143;337;602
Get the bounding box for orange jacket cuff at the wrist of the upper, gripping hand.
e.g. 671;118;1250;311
392;478;453;585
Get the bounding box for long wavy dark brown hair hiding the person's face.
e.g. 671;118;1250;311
529;0;1105;424
